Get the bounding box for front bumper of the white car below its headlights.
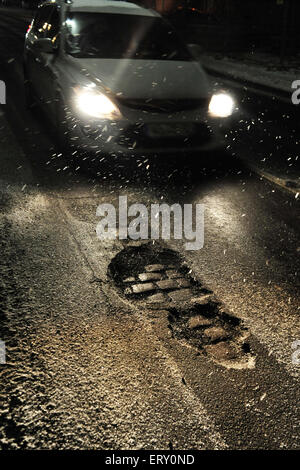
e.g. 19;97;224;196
64;105;231;159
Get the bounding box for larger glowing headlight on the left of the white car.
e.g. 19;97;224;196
75;87;121;120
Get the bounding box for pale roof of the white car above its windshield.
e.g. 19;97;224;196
68;0;160;17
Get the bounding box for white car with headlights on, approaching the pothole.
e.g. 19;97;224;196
24;0;235;161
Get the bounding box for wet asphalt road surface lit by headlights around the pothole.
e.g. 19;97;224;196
0;9;300;450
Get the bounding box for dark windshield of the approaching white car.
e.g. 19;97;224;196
66;12;191;61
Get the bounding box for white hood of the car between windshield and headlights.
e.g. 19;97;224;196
70;58;208;99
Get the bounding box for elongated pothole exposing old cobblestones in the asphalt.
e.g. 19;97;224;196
108;244;255;368
